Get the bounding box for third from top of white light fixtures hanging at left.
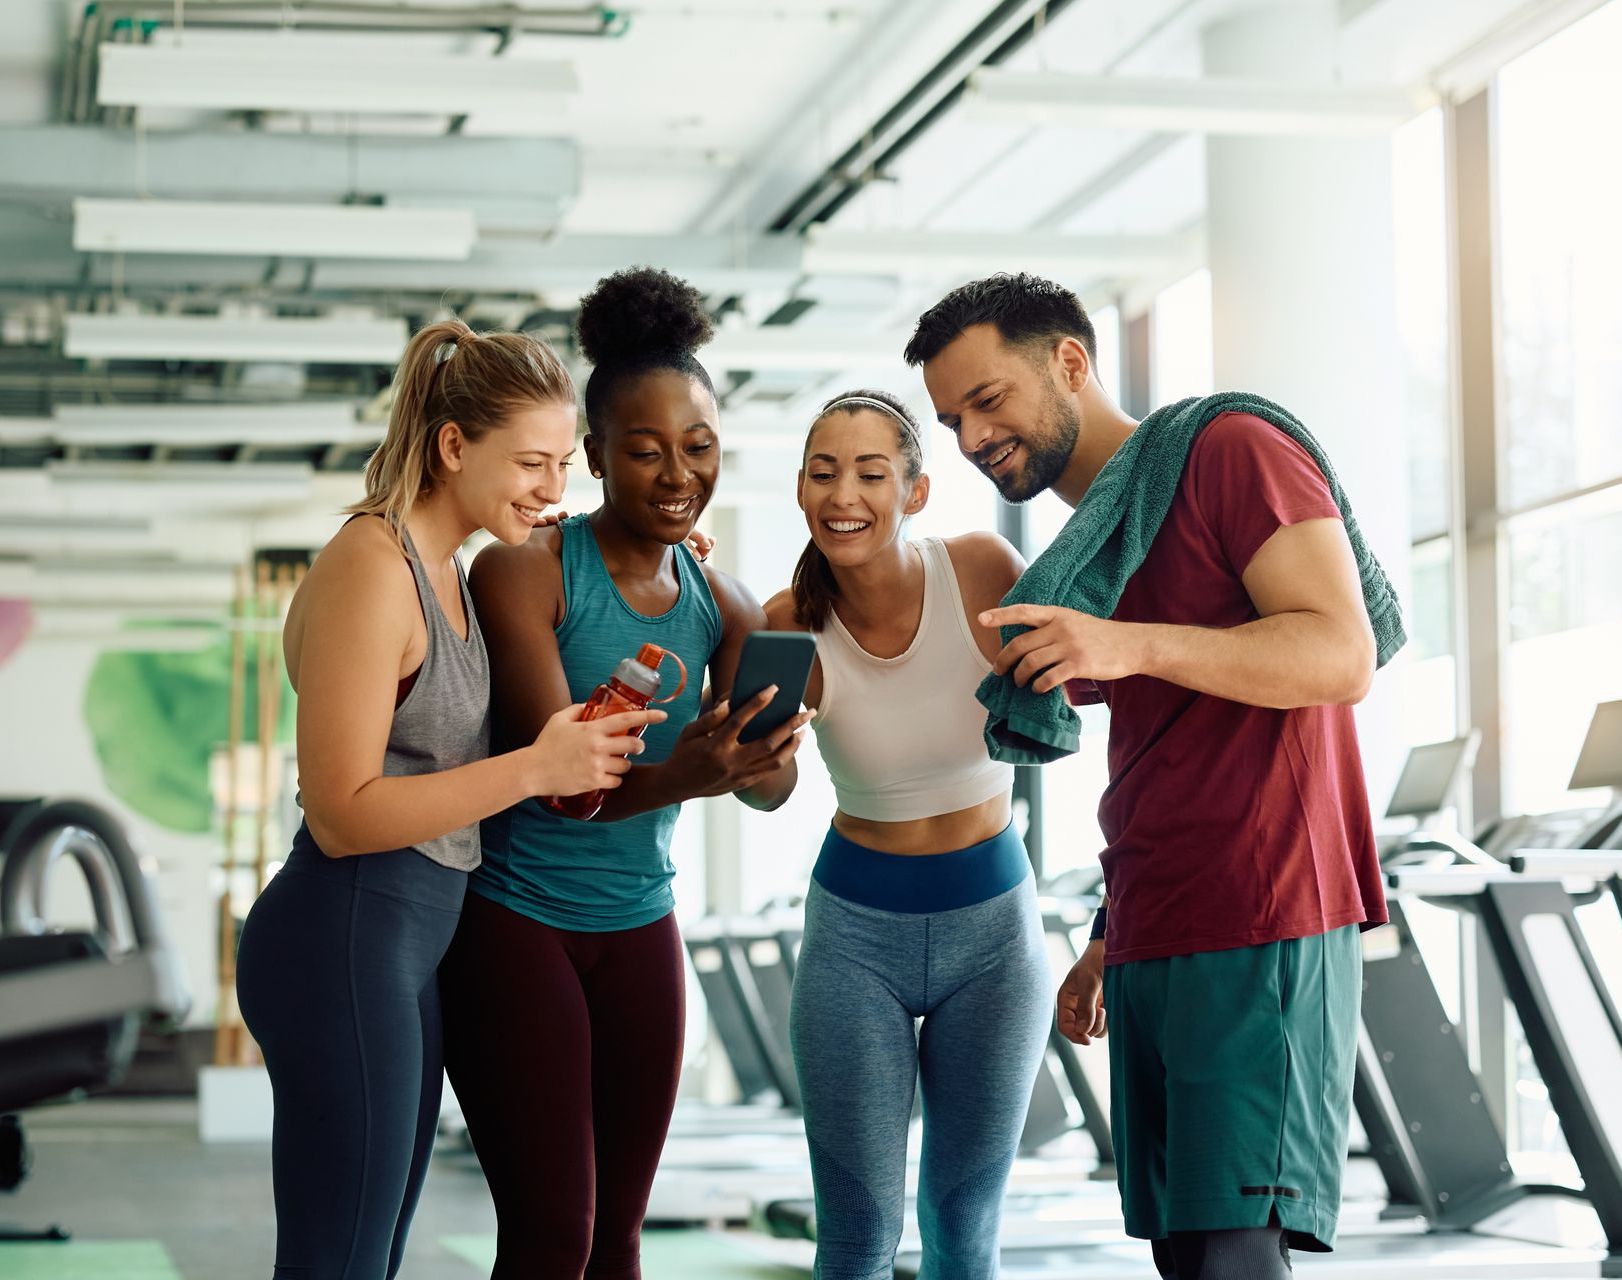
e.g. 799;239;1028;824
63;315;407;365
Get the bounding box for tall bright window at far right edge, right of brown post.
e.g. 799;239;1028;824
1497;3;1622;813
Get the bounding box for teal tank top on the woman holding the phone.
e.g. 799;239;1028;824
469;516;722;933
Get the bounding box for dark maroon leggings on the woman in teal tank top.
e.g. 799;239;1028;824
440;894;686;1280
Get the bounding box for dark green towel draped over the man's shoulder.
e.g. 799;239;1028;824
975;391;1408;764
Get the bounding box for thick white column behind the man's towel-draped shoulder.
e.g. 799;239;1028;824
1202;0;1410;811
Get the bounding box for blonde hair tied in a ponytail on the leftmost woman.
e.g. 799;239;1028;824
344;320;574;545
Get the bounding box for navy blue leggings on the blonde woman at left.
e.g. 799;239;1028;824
237;827;467;1280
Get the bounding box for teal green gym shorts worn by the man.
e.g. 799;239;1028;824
1105;925;1362;1252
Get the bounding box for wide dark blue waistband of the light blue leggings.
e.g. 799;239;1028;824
811;823;1030;915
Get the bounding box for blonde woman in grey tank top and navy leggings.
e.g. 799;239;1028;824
237;321;663;1280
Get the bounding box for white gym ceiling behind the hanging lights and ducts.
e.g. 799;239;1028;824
0;0;1599;594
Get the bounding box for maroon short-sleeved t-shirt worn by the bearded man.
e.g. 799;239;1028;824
1069;414;1387;964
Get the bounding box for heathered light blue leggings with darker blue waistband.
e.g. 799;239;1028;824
792;834;1053;1280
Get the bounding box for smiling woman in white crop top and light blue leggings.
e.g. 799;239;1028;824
766;391;1053;1280
